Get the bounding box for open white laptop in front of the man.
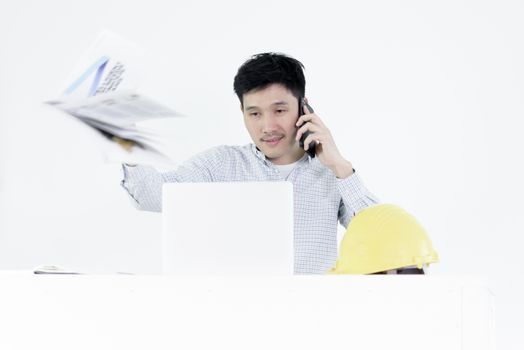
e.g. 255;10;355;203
162;181;294;275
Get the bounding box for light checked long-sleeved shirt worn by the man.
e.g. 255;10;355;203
122;144;378;274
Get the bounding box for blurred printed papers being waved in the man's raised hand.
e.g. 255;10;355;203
47;31;181;163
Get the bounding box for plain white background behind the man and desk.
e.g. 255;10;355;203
0;0;524;349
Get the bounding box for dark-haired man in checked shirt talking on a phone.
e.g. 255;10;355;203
122;53;377;274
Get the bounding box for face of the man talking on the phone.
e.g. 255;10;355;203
242;84;304;164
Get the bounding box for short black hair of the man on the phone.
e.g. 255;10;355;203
233;52;306;105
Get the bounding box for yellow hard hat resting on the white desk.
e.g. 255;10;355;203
330;204;438;274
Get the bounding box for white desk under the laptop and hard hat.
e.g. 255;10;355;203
0;272;493;350
